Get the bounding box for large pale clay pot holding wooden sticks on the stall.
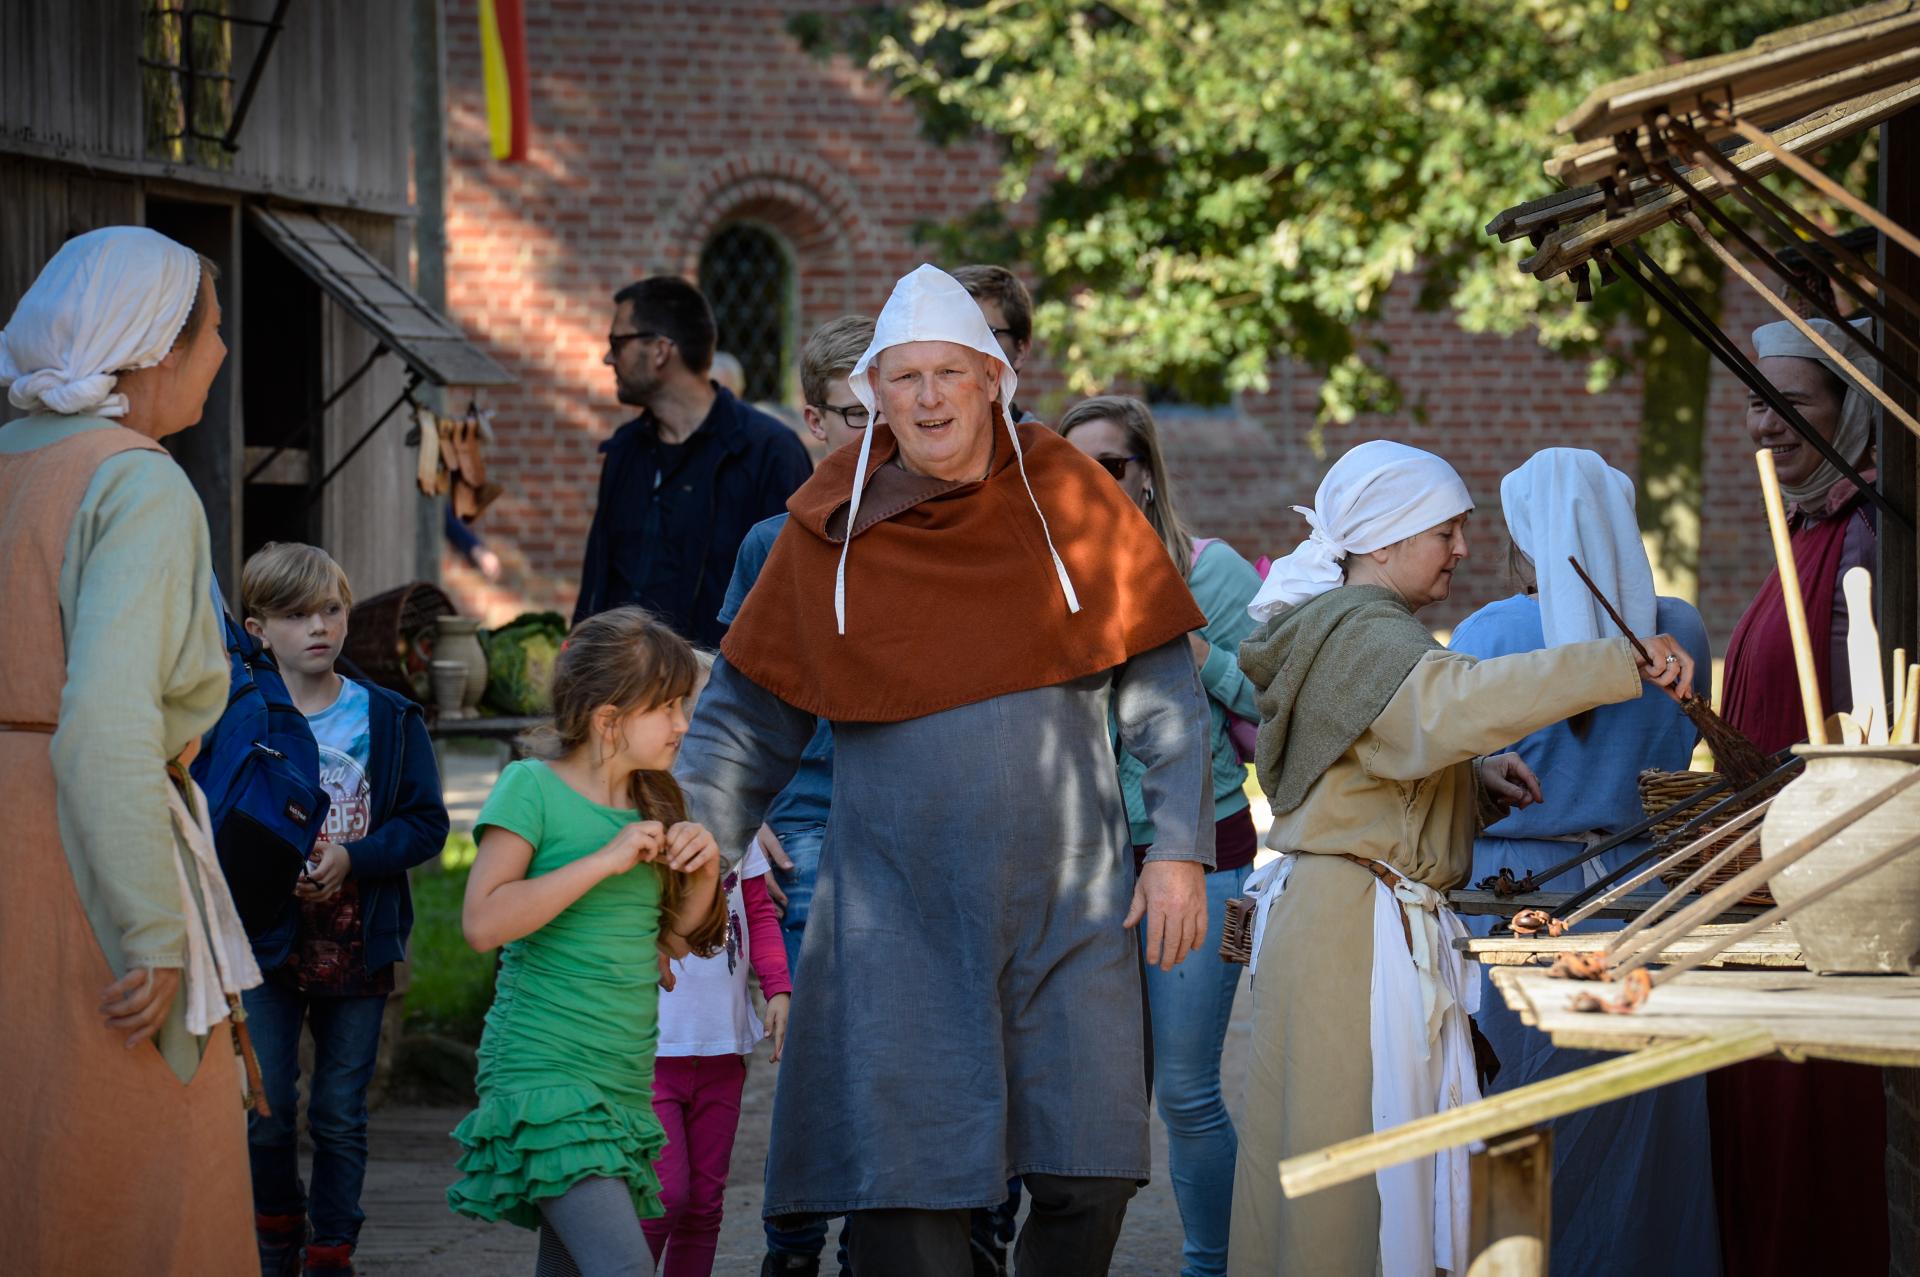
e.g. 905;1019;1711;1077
1761;745;1920;976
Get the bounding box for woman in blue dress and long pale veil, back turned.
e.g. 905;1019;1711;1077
1450;447;1720;1277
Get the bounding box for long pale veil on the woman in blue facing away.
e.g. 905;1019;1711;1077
1500;447;1657;647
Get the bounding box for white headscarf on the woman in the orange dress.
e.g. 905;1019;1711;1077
0;227;200;417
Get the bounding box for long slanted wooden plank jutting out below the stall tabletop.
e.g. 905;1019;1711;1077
1281;1029;1774;1196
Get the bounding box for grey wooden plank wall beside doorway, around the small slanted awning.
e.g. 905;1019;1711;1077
319;215;432;599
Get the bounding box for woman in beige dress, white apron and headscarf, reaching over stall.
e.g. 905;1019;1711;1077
1229;440;1693;1277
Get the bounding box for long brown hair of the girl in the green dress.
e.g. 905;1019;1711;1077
541;607;726;956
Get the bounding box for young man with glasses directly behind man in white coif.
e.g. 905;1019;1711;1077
720;315;874;1277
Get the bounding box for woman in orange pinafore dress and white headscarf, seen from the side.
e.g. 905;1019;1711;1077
0;227;259;1275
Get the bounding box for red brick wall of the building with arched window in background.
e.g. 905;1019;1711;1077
447;0;1766;647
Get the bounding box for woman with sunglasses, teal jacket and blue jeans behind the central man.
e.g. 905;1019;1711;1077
1058;396;1260;1277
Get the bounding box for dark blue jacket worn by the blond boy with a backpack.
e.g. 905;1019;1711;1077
253;680;447;972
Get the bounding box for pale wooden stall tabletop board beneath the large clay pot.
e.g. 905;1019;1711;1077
1492;966;1920;1066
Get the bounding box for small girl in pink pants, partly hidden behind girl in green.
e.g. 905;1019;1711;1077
641;841;793;1277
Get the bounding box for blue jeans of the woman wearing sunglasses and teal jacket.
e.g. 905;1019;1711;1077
1140;866;1252;1277
